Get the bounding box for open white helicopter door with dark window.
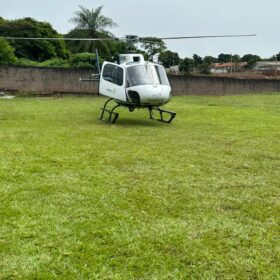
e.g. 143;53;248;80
99;62;126;101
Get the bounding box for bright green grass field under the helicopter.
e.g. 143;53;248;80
0;94;280;279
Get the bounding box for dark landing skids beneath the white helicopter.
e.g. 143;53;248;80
99;98;176;124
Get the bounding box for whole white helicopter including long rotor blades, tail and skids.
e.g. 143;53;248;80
0;34;256;124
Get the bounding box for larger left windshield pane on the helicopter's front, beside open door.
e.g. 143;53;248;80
127;65;154;87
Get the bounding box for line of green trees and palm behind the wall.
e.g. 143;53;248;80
0;6;280;74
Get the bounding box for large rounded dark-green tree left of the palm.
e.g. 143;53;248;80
0;18;69;61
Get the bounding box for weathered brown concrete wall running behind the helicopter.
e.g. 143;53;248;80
0;66;280;95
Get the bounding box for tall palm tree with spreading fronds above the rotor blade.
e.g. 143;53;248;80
67;6;117;55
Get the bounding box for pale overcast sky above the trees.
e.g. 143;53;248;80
0;0;280;58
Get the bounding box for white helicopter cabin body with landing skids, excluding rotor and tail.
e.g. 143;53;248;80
99;50;176;123
